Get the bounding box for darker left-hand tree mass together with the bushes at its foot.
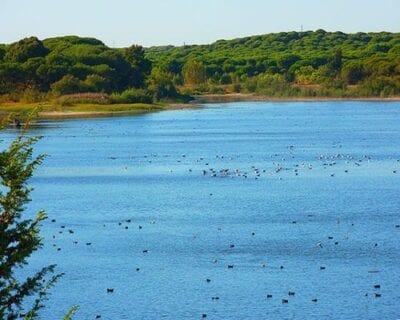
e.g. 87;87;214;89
0;36;177;103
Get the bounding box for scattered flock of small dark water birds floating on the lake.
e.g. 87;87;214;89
43;145;400;319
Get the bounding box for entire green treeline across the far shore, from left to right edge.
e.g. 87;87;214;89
0;30;400;103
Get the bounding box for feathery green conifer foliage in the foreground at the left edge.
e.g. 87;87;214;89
0;134;62;320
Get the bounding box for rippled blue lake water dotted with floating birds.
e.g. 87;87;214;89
2;102;400;320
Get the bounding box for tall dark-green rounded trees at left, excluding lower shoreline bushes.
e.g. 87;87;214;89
0;36;151;94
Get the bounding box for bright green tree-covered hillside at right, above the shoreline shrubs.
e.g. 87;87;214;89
146;30;400;83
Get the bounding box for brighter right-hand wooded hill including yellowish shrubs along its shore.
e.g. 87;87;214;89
146;30;400;96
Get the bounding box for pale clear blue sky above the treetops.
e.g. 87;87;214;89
0;0;400;47
